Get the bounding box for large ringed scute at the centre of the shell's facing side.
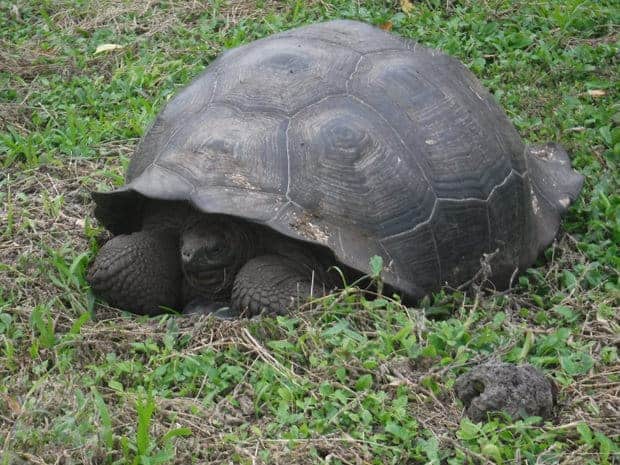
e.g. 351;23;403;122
288;95;435;237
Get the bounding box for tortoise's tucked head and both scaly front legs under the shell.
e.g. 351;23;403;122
87;202;334;317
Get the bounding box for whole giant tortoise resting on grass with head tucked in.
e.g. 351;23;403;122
88;21;582;315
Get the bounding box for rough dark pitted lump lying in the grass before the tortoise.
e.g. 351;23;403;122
454;363;556;421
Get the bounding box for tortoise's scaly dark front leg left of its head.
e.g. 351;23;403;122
87;231;181;315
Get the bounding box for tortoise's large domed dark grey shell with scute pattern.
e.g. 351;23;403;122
94;21;582;298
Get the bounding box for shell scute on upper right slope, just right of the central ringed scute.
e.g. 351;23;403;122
349;51;512;199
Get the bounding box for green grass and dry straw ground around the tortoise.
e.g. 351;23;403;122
0;0;620;465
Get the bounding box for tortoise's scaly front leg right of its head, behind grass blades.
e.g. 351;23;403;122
232;255;325;316
